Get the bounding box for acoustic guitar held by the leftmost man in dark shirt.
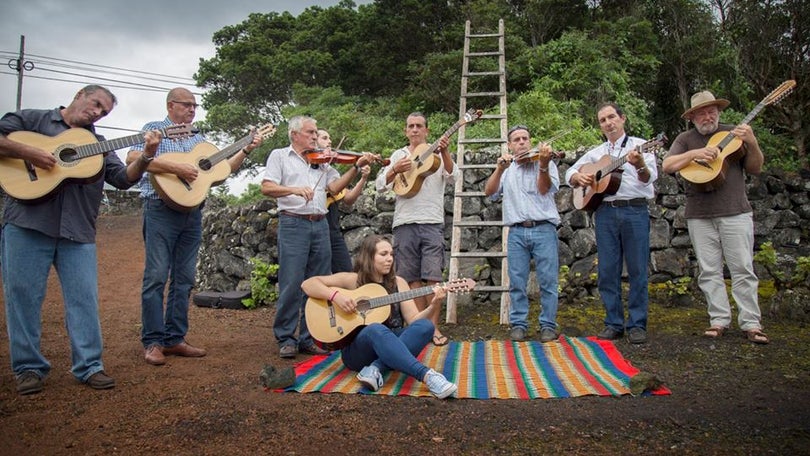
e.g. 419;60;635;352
0;124;197;203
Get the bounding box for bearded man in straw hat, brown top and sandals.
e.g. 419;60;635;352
662;91;768;344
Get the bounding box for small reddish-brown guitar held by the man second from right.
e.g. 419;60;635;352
573;133;667;211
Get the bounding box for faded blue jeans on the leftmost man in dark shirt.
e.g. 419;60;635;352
0;224;104;382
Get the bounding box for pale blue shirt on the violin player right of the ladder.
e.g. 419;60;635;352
490;161;560;226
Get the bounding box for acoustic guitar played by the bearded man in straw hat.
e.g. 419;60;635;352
679;79;796;192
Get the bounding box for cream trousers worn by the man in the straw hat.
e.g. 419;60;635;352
687;212;762;331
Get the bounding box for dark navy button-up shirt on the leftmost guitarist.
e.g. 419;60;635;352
0;106;133;244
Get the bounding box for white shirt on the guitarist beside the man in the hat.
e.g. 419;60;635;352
565;135;658;201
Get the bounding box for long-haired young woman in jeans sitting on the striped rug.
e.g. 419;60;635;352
301;235;458;399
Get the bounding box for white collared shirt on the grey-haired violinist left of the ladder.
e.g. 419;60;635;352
262;145;340;215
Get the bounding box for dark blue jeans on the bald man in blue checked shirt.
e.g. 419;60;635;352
141;199;202;347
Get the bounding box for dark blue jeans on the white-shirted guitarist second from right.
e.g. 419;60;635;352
596;204;650;332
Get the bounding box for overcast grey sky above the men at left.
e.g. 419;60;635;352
0;0;370;192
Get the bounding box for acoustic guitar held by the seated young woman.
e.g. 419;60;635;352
304;279;475;350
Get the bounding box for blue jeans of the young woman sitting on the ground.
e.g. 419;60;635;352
340;318;433;382
